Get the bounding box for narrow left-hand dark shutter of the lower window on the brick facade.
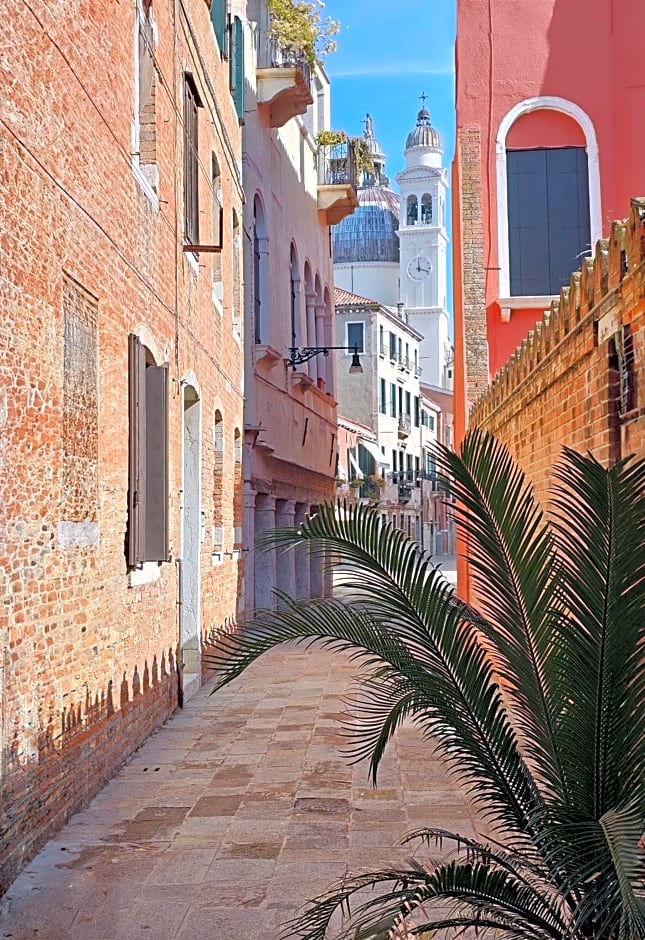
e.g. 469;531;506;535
128;335;146;568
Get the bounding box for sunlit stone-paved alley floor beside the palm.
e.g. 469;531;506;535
0;647;480;940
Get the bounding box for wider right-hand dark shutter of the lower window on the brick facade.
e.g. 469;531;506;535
145;364;169;561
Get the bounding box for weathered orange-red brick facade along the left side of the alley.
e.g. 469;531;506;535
0;0;243;890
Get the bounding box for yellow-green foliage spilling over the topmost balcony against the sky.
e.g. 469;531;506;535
269;0;340;68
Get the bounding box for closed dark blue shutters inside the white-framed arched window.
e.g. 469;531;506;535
506;147;591;297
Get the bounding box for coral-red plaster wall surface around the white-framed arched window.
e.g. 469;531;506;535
455;0;645;384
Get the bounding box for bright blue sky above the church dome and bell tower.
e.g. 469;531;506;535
323;0;456;318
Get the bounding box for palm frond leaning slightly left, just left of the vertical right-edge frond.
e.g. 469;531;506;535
437;428;566;799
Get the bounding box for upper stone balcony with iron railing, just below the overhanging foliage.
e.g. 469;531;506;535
257;35;314;127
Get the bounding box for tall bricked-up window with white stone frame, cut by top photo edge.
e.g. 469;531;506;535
135;0;159;192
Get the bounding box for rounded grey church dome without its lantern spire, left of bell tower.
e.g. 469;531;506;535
332;185;399;264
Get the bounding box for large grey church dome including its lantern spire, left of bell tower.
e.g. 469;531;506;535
332;114;399;264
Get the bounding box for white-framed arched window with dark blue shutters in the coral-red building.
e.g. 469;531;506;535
496;97;601;299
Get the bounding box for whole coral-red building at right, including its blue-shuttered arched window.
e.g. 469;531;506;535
452;0;645;438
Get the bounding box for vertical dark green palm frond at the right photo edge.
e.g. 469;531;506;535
553;450;645;820
